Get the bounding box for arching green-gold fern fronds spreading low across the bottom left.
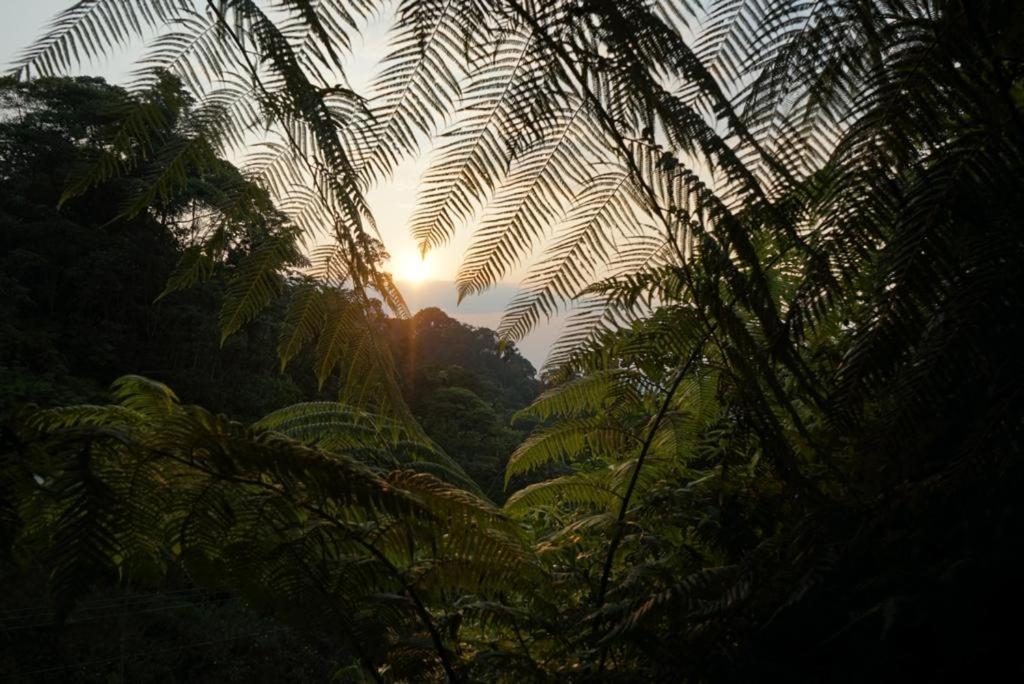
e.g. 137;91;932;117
4;377;543;671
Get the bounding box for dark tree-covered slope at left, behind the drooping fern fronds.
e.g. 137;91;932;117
0;74;311;419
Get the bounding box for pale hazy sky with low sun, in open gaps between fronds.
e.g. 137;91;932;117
0;0;559;368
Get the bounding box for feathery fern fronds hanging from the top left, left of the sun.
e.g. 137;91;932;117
15;0;423;415
